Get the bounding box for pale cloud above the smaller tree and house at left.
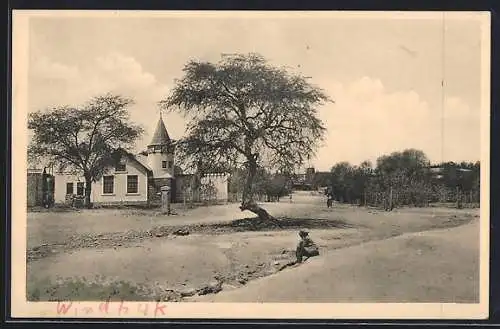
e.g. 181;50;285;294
29;53;184;149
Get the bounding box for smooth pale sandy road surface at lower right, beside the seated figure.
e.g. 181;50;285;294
192;220;479;303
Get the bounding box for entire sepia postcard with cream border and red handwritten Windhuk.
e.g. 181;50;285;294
11;10;490;319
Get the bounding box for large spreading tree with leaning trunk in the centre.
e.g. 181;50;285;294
160;54;330;219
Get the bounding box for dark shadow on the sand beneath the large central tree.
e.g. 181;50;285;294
211;217;354;232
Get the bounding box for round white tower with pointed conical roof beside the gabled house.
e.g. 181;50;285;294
148;114;175;180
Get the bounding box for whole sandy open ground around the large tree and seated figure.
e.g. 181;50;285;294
28;193;479;302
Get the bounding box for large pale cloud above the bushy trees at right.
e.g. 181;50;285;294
314;77;480;170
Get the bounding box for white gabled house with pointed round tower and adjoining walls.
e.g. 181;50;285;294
34;117;229;205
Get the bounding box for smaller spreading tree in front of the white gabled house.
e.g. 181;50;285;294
28;94;143;207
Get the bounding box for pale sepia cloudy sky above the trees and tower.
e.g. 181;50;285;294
24;13;488;170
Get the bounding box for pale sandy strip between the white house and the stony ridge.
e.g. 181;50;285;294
27;195;317;248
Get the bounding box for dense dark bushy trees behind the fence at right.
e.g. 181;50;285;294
330;149;480;206
